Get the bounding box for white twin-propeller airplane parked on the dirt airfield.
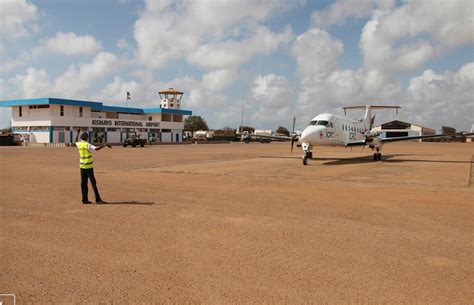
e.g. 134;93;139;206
254;105;474;165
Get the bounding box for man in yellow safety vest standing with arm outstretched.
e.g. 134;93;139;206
76;132;112;204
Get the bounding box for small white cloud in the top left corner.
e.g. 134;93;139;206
0;0;38;39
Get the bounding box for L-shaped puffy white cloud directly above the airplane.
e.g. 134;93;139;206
292;28;401;122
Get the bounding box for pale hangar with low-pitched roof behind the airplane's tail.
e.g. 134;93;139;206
372;120;436;142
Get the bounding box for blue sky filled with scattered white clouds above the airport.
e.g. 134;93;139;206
0;0;474;130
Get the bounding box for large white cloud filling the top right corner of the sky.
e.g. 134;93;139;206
359;0;474;73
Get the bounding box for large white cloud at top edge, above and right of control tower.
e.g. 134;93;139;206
134;0;299;70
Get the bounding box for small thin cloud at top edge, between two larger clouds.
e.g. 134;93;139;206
311;0;395;28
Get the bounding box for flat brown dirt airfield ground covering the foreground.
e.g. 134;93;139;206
0;142;474;304
